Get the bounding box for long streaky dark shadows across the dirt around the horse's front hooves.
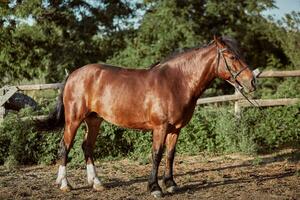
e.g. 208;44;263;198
105;149;300;194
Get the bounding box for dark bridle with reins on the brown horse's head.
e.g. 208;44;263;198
216;47;259;107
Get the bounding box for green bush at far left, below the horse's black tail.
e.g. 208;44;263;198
0;109;59;165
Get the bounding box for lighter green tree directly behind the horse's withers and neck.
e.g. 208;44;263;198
108;1;199;68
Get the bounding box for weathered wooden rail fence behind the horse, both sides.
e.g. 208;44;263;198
0;70;300;121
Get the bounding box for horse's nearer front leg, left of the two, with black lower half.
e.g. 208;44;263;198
148;125;167;197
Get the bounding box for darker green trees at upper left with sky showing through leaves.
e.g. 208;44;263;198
0;0;135;83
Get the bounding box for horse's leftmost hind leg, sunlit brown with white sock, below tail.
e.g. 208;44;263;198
56;120;81;192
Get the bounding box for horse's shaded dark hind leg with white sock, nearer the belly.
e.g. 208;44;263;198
82;113;104;191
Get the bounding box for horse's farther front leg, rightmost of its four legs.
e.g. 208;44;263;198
163;130;180;193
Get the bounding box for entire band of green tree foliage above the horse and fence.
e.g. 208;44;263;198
0;0;300;83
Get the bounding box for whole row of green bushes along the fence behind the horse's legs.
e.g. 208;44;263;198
0;104;300;166
